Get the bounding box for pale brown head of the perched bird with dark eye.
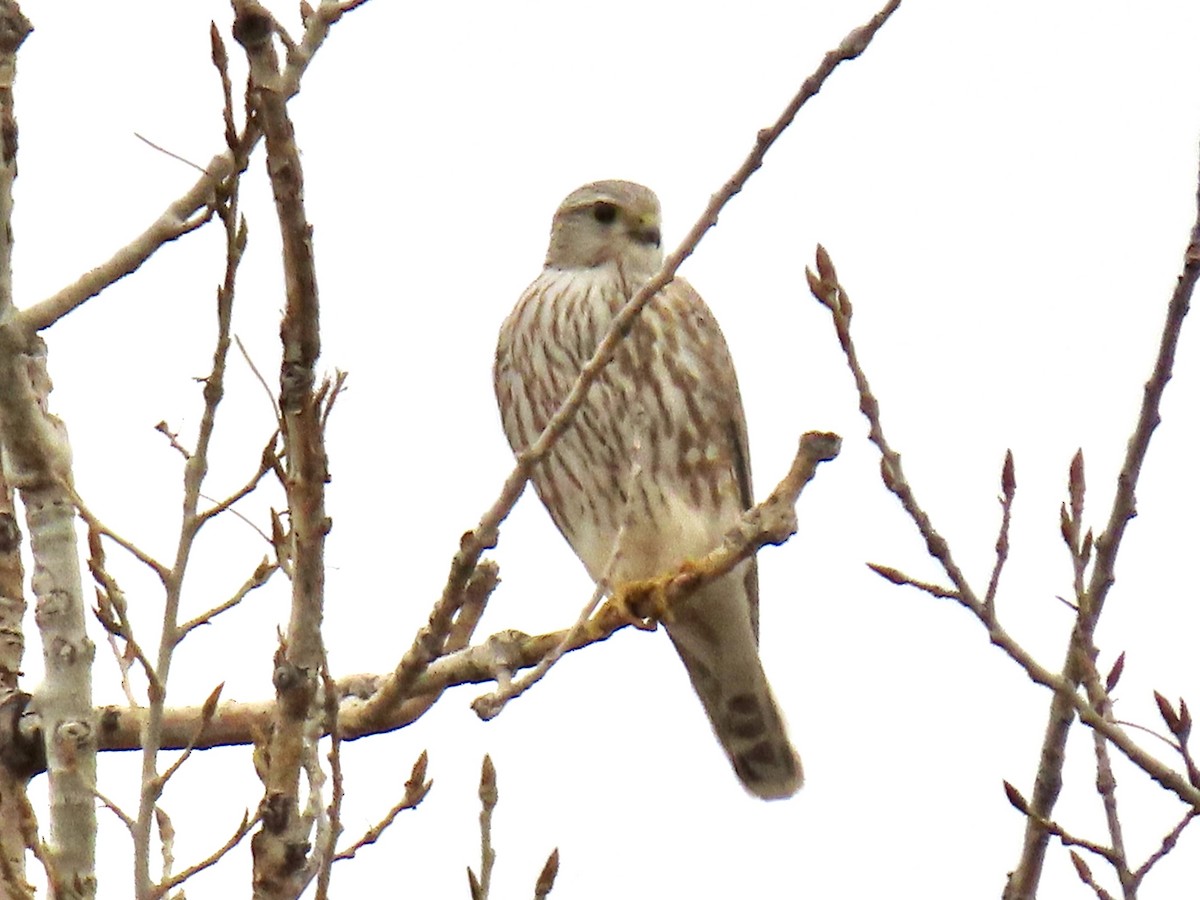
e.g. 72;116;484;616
546;181;662;277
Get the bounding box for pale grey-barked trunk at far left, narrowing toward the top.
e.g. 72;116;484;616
0;0;96;899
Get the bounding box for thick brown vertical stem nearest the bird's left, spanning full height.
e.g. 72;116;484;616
233;0;336;898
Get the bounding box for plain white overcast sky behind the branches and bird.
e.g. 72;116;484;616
14;0;1200;898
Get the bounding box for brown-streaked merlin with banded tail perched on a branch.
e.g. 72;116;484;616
494;181;804;799
